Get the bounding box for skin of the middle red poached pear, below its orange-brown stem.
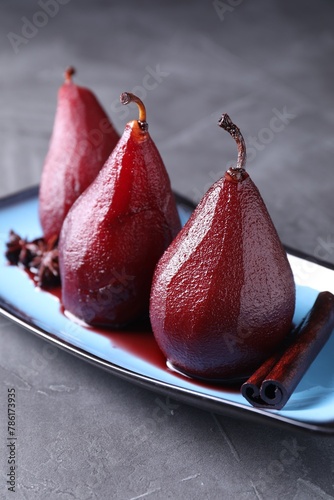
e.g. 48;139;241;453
59;122;180;327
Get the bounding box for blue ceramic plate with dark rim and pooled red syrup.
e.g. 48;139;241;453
0;188;334;434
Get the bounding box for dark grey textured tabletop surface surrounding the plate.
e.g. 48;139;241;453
0;0;334;500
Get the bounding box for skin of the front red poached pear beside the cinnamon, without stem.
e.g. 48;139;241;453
150;174;295;380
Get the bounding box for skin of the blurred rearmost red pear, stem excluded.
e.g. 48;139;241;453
39;81;119;239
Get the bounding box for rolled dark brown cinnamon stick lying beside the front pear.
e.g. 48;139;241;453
241;292;334;410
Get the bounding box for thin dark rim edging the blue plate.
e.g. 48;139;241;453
0;186;334;436
